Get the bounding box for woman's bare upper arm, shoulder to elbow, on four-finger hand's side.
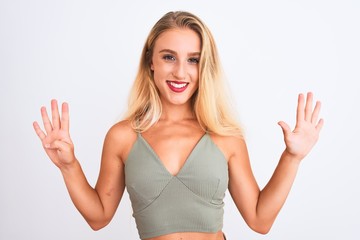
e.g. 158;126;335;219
95;123;135;221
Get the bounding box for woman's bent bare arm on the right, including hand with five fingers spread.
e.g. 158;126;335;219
229;93;323;234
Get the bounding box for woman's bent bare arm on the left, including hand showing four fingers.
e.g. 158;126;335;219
34;100;125;230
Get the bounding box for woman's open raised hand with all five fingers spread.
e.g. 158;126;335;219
278;92;324;160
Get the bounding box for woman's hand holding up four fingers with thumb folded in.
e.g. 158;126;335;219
33;100;76;169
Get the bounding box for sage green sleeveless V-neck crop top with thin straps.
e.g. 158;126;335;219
125;133;229;239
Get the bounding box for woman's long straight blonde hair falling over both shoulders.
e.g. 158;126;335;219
125;11;242;136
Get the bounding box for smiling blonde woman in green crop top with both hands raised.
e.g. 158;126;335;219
34;12;323;240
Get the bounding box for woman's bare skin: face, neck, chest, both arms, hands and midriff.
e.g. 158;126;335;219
34;29;323;240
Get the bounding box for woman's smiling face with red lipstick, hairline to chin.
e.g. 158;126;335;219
151;29;201;105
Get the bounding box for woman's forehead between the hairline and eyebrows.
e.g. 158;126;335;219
154;28;201;52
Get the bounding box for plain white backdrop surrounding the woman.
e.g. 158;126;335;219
0;0;360;240
